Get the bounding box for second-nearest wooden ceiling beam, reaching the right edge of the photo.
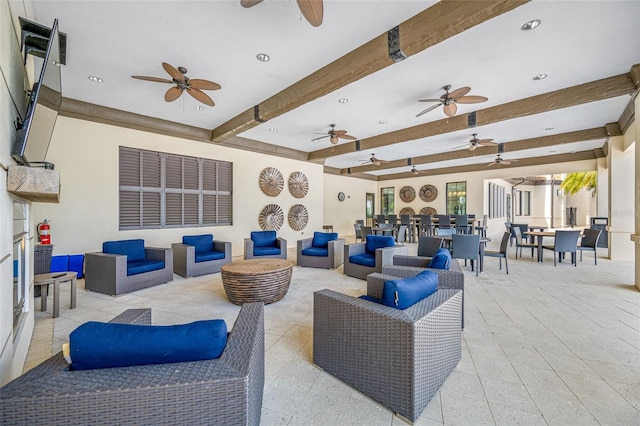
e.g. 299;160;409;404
309;65;640;160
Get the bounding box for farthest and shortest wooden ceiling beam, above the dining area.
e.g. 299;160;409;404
378;150;597;181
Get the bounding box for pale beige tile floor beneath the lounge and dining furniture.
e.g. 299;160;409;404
26;236;640;426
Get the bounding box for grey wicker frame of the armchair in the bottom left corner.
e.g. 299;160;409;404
0;303;264;425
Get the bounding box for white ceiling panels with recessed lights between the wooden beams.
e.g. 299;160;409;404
33;0;640;175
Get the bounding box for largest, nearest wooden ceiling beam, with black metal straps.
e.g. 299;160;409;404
211;0;529;142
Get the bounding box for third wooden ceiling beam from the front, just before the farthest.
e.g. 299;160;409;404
341;127;608;175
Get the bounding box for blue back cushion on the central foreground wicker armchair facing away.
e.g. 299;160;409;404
382;271;438;309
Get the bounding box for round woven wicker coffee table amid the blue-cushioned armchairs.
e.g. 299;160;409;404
221;258;293;305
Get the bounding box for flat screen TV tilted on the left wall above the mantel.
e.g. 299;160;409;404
11;19;62;168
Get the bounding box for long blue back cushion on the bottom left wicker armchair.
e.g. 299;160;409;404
69;319;227;370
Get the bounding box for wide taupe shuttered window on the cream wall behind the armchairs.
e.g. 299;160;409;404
119;147;233;230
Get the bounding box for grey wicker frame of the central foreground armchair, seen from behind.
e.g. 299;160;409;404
313;289;462;422
